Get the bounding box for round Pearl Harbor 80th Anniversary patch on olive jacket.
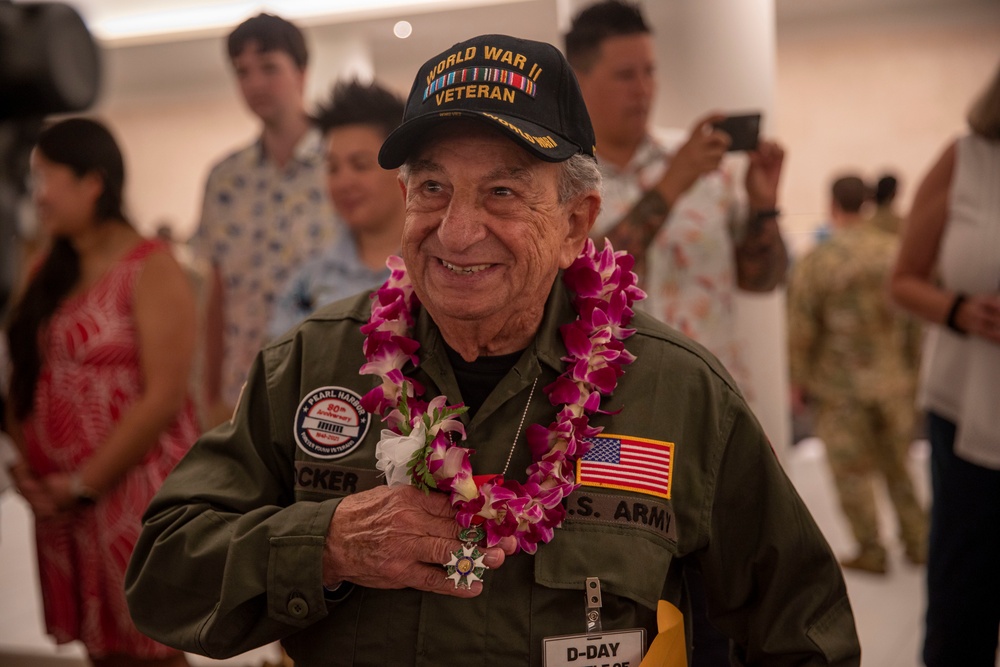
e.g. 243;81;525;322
295;387;371;459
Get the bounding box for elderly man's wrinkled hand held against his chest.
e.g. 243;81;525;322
323;486;516;597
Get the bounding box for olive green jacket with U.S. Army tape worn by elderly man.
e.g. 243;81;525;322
126;280;860;667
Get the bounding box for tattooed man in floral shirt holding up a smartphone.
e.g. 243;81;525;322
565;0;788;402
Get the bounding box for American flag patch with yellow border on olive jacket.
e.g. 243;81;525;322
576;434;674;498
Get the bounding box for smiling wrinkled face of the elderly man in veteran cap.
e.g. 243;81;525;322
403;120;596;322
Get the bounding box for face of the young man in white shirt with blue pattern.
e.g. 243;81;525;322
233;42;305;124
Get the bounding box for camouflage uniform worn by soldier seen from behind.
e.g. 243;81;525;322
788;224;927;562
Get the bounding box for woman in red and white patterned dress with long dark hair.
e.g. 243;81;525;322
1;118;198;667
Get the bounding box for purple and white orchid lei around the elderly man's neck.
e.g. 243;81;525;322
360;239;646;553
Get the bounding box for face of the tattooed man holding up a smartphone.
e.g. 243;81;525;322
576;33;656;150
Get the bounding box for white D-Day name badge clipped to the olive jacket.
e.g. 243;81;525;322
542;628;646;667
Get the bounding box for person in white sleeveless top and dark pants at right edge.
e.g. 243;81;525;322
891;60;1000;667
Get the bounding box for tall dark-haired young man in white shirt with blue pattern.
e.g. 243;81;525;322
192;14;339;425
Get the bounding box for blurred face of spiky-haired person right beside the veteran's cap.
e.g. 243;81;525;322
326;125;403;231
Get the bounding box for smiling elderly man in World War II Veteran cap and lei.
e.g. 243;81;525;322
128;35;859;667
